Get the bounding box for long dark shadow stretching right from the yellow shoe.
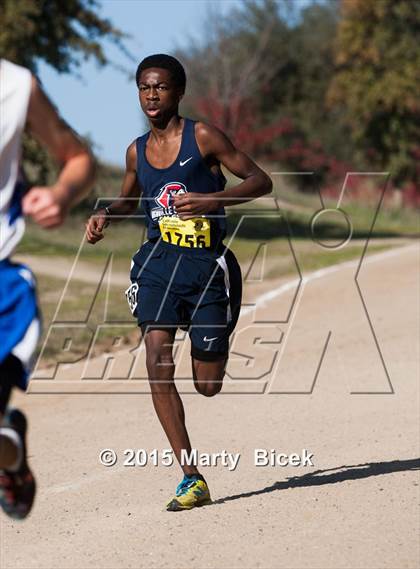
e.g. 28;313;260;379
213;458;420;505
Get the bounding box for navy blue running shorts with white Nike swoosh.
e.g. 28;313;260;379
125;240;242;361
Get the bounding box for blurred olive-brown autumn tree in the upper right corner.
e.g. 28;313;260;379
328;0;420;191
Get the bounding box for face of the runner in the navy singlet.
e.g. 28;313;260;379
139;67;182;123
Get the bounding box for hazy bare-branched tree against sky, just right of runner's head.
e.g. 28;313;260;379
178;0;288;141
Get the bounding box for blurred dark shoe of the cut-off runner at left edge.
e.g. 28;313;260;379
0;409;36;520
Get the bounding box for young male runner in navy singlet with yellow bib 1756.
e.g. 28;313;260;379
87;54;272;511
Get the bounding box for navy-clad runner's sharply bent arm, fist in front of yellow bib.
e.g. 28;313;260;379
174;123;273;219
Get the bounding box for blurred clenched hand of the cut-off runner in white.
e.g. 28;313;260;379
22;186;68;229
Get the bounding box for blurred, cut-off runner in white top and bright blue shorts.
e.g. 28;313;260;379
0;59;94;519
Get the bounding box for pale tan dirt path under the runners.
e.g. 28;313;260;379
0;241;420;569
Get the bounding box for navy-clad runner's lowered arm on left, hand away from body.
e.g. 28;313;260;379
86;142;141;245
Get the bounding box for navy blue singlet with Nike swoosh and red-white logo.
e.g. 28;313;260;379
136;118;226;249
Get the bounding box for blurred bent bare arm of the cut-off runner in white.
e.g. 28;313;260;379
22;77;95;228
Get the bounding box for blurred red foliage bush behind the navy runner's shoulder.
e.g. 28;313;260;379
194;95;420;208
